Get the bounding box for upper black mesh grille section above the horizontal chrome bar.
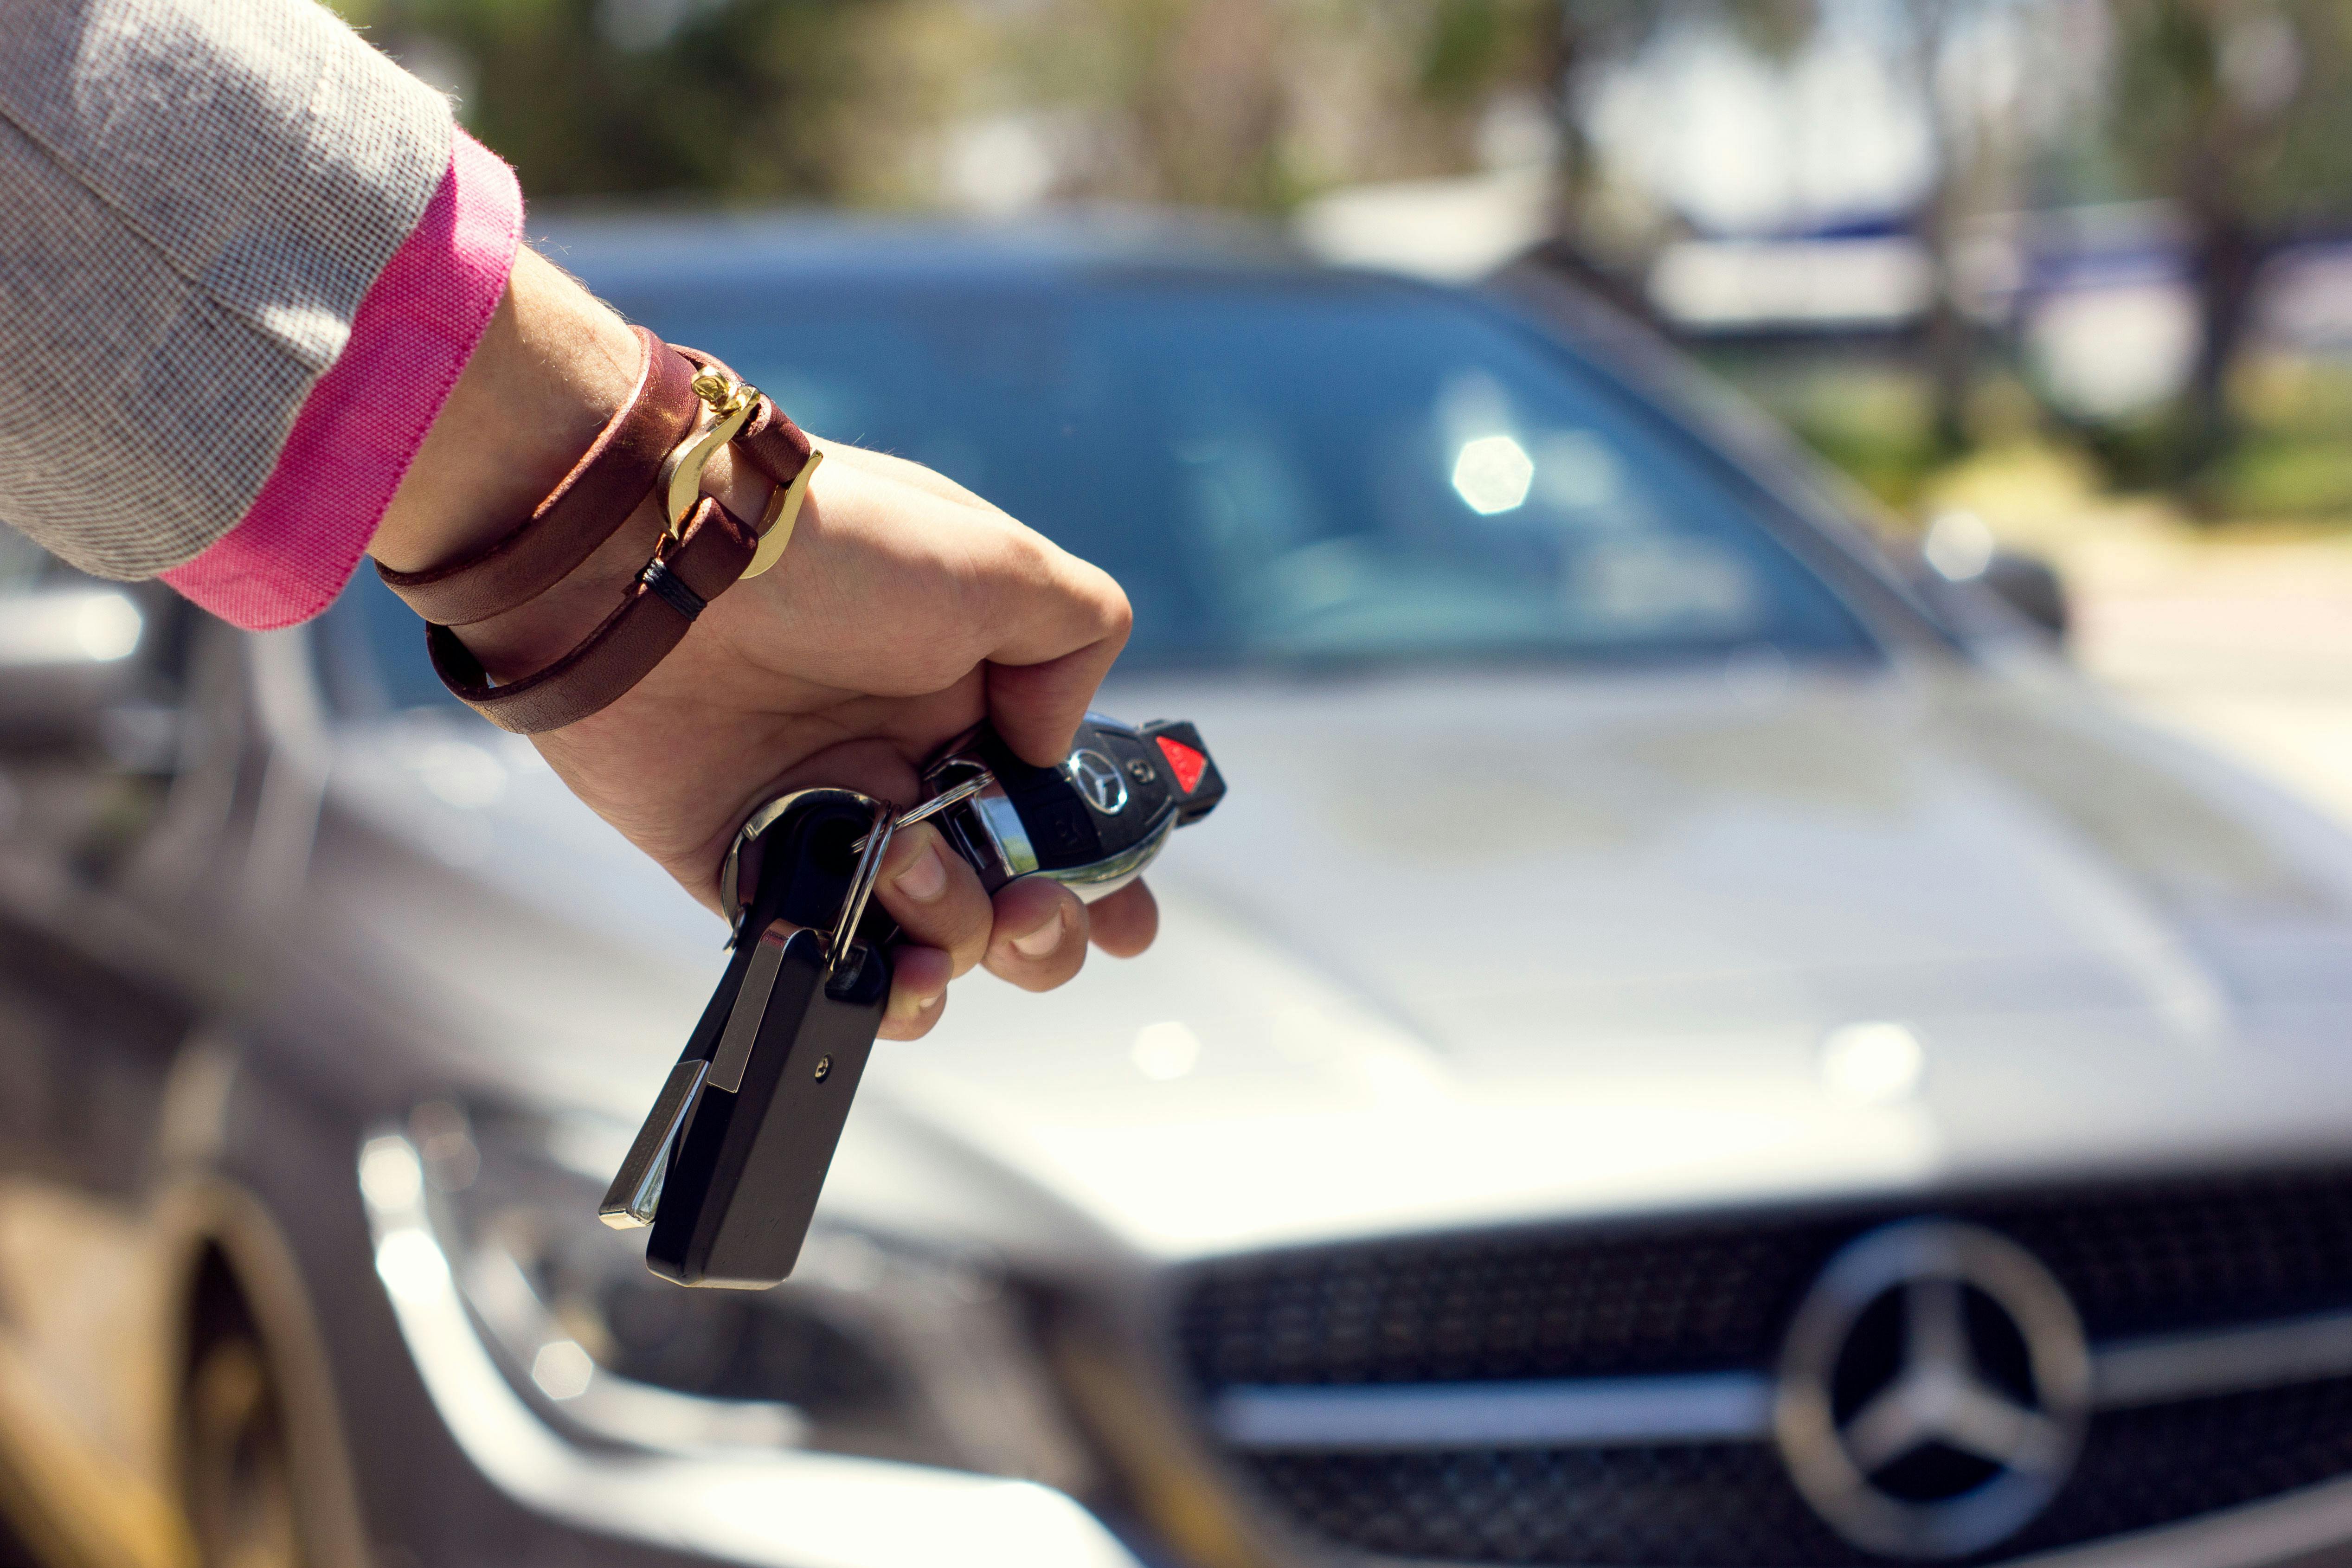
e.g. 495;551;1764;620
1178;1171;2352;1389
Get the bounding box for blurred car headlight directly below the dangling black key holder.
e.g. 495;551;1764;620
374;1103;1091;1491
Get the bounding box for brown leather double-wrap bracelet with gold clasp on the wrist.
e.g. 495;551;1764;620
379;327;816;736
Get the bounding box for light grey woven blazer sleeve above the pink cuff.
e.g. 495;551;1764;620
0;0;451;578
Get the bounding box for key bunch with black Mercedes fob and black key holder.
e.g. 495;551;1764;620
600;712;1225;1291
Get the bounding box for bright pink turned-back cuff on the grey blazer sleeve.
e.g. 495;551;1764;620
162;132;522;632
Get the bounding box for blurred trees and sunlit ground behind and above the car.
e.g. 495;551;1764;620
336;0;2352;811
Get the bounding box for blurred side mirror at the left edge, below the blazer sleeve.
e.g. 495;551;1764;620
0;578;160;747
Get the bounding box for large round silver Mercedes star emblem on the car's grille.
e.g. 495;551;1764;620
1774;1220;2091;1556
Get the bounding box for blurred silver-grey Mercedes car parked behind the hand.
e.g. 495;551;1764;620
0;221;2352;1568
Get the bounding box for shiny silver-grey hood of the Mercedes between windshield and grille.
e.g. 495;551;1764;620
317;668;2352;1255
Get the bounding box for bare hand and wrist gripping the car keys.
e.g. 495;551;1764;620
374;251;1157;1039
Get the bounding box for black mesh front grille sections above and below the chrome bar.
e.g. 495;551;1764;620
1176;1171;2352;1568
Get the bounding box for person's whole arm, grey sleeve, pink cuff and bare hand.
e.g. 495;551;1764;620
0;0;1155;1037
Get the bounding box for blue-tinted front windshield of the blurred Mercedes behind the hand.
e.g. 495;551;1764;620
327;273;1872;698
